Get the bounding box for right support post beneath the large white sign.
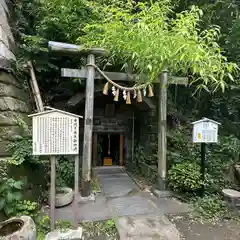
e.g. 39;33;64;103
73;155;79;229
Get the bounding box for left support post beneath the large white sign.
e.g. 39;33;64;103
50;156;56;231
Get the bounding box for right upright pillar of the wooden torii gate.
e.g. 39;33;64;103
158;70;168;190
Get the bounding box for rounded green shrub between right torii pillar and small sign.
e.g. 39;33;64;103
168;162;203;192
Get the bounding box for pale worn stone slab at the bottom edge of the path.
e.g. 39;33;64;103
116;215;181;240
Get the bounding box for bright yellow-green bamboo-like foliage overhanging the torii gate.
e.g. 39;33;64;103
79;0;236;90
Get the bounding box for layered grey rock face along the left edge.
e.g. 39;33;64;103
0;0;31;158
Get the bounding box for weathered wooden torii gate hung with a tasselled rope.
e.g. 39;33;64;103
48;41;188;197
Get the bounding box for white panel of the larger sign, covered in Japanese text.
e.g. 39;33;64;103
30;112;79;155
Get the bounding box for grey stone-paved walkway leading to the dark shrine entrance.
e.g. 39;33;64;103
51;167;188;240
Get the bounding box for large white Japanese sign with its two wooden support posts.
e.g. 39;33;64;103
29;108;82;230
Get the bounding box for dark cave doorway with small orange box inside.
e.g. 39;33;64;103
93;133;124;167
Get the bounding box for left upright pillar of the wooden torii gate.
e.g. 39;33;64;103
82;54;95;197
